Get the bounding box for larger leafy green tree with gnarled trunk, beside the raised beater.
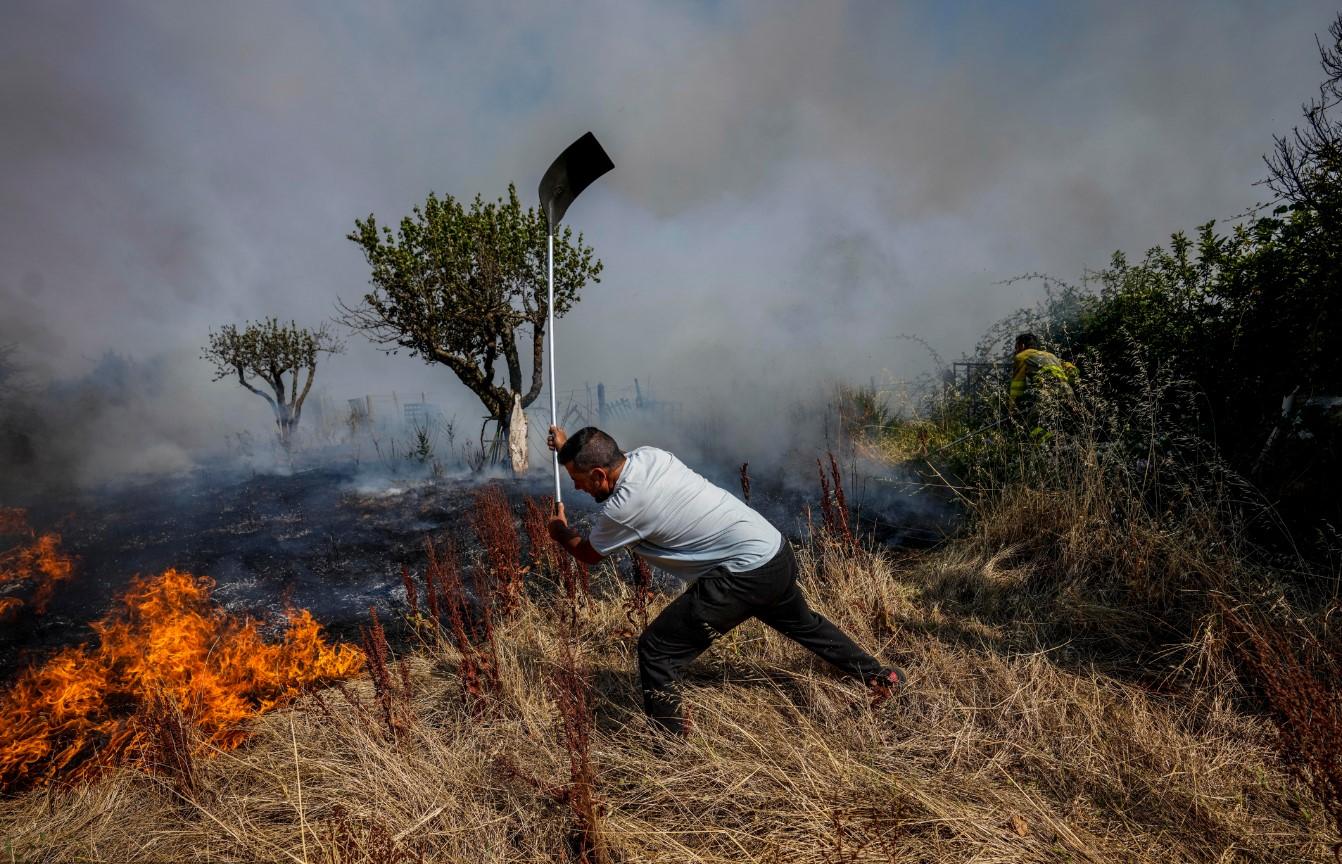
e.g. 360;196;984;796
341;185;601;466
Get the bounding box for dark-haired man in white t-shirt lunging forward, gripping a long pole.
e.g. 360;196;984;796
549;427;906;734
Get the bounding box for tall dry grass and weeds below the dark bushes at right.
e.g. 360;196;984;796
858;356;1342;849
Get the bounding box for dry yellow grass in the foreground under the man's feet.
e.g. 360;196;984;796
0;528;1333;864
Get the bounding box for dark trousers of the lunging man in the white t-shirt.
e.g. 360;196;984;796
639;538;883;733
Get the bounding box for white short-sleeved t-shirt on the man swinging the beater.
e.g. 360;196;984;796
588;447;782;580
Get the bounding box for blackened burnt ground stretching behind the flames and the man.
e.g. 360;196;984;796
0;456;953;682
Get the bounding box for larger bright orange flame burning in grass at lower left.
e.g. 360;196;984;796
0;570;364;794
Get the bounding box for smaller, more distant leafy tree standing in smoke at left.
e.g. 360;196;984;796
201;318;342;451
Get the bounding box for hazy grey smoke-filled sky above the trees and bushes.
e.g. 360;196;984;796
0;0;1337;478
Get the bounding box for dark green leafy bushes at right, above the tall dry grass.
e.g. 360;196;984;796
987;204;1342;543
